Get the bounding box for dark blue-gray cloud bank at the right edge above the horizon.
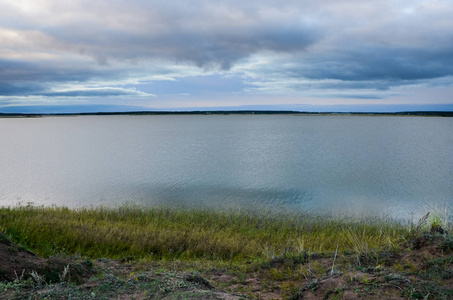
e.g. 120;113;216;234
292;44;453;81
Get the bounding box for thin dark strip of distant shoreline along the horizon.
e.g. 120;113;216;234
0;110;453;118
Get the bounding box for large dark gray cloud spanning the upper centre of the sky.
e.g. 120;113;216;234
40;10;322;70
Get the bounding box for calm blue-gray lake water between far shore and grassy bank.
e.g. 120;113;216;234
0;115;453;220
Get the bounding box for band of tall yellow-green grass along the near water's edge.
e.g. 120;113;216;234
0;205;424;261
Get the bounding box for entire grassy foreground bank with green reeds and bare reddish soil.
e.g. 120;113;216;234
0;206;453;299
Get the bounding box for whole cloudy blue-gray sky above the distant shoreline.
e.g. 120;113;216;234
0;0;453;113
